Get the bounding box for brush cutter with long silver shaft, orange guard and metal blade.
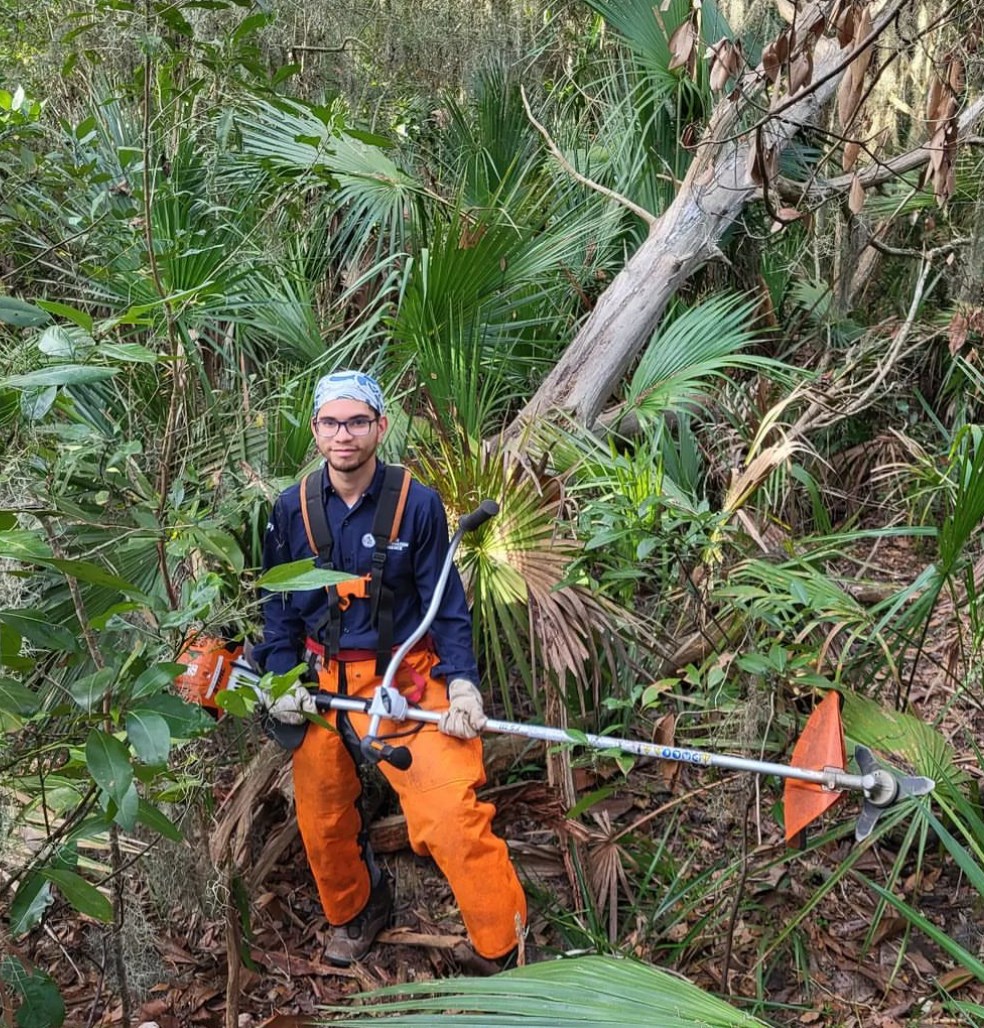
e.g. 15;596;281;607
172;500;936;842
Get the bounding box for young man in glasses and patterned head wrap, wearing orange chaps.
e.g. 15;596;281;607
254;371;526;965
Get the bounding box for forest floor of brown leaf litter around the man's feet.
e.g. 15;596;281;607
24;723;984;1028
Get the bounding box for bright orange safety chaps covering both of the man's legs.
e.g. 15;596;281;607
293;650;526;960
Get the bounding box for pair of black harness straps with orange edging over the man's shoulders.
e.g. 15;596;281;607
300;464;410;675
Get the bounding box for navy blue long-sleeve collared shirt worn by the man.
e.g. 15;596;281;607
253;462;478;683
